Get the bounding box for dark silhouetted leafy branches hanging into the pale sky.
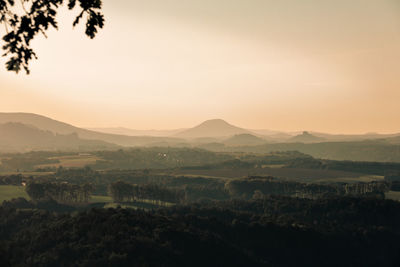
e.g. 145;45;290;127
0;0;104;74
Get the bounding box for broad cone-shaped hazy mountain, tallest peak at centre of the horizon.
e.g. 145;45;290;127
174;119;251;139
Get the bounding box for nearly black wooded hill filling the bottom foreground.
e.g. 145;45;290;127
0;197;400;266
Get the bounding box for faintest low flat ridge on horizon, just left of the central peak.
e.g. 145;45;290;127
87;127;186;137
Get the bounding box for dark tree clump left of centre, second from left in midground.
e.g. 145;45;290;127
109;181;185;205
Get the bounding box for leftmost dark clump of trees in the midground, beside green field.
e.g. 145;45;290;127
26;182;94;203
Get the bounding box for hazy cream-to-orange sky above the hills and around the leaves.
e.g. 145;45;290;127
0;0;400;134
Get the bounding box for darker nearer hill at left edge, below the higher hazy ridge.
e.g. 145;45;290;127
0;122;118;152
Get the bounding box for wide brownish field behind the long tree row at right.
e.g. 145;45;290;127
171;167;383;183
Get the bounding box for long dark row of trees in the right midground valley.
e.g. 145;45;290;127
225;176;389;199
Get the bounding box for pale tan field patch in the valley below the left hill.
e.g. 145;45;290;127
36;154;100;168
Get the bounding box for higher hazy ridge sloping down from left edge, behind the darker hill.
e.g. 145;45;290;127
0;113;184;146
